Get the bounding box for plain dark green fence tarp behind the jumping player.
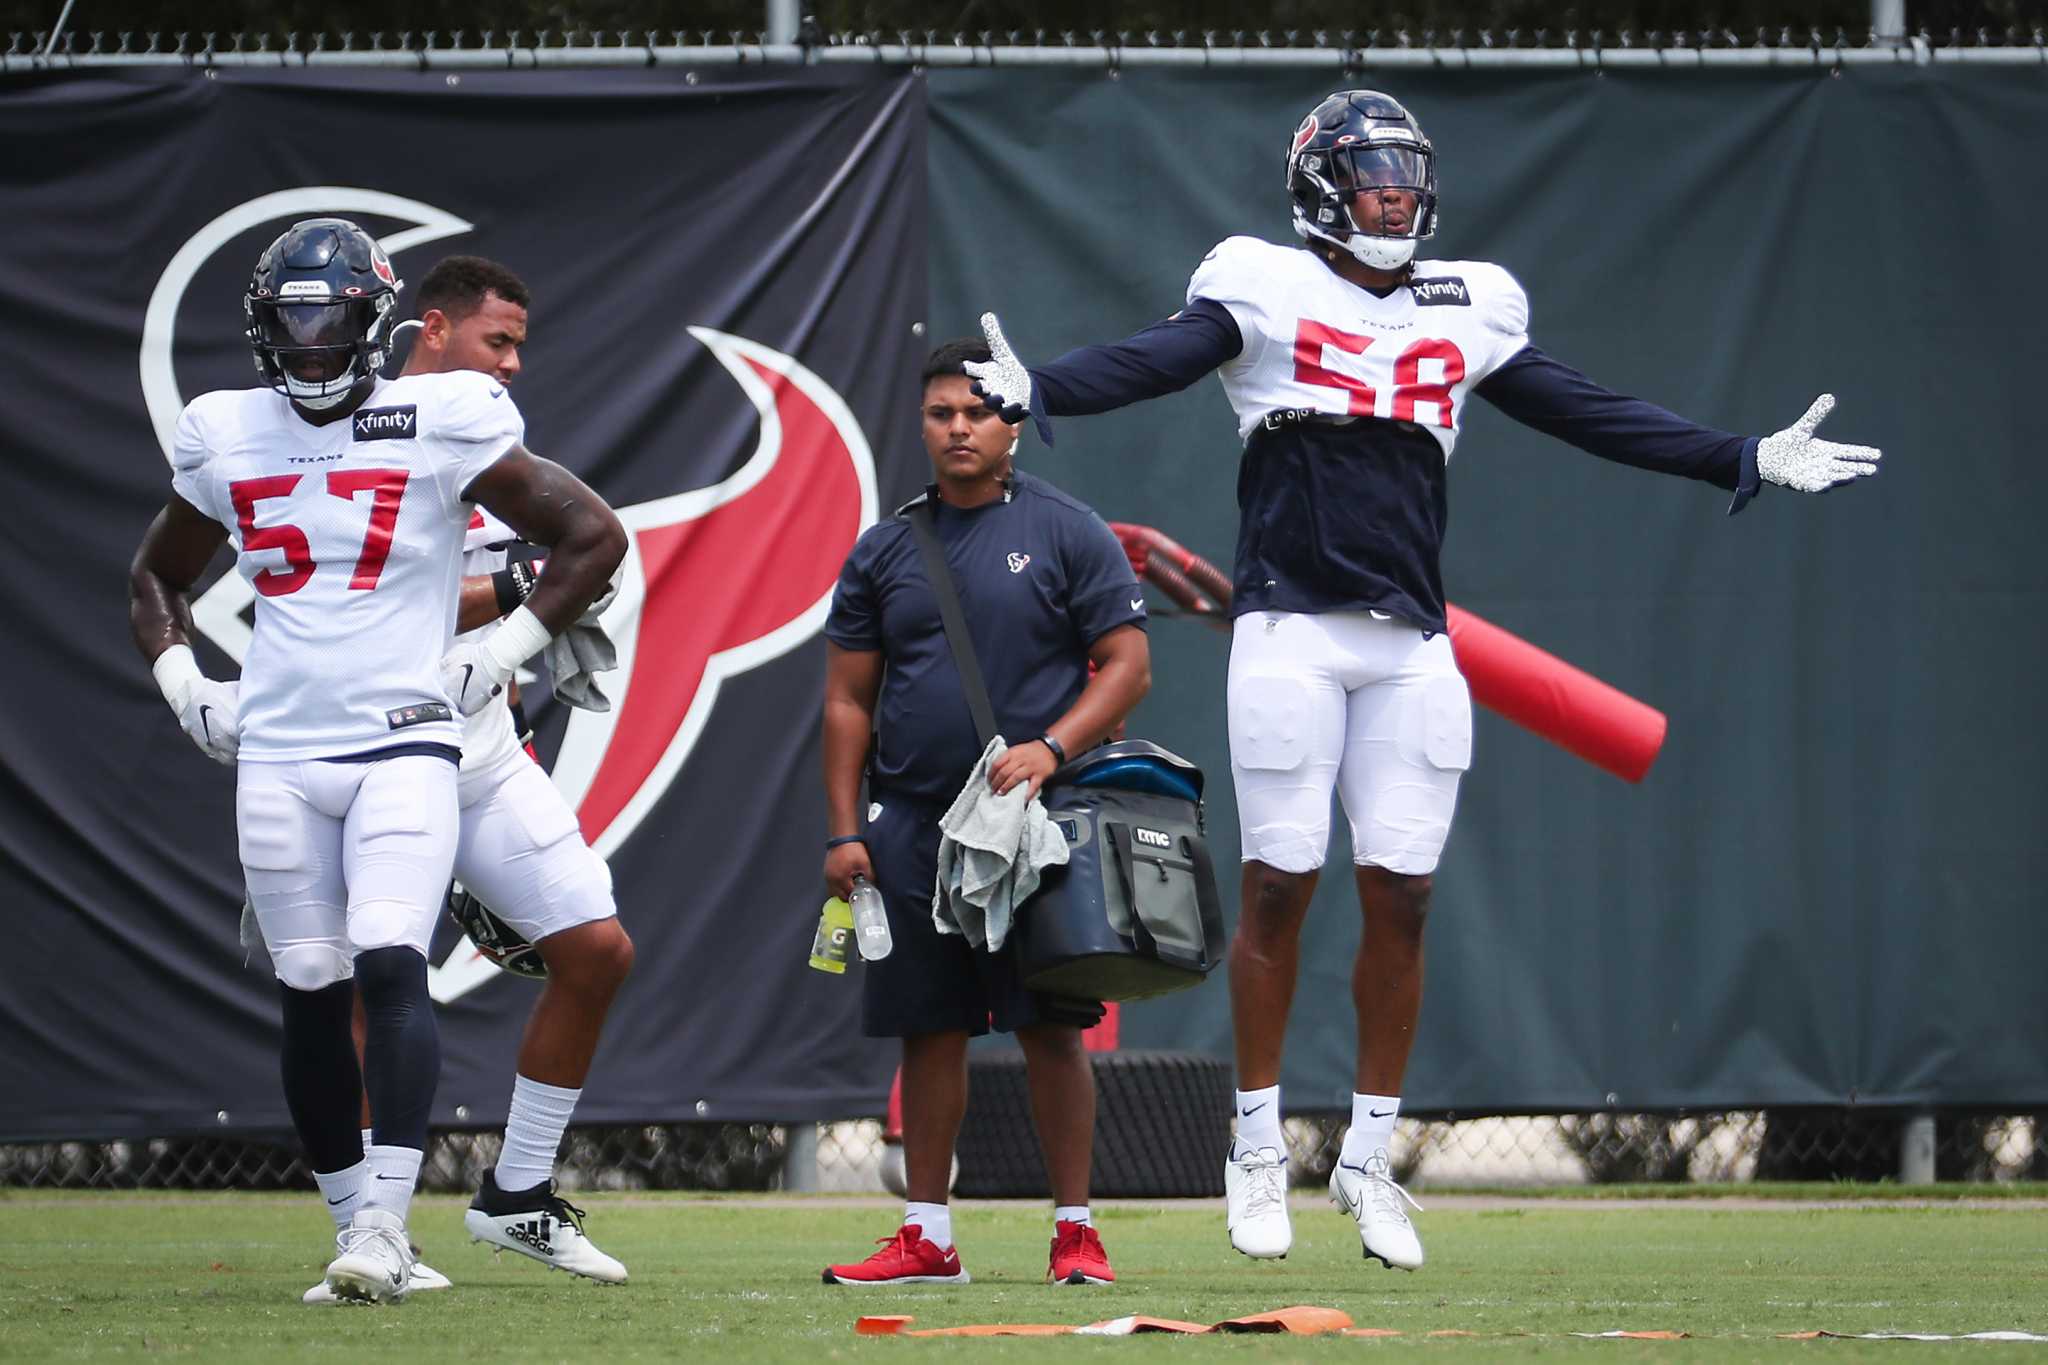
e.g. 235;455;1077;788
929;68;2048;1111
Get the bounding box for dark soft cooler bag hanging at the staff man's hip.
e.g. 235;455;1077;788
1012;739;1225;1001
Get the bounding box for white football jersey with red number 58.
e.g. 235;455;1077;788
1188;237;1530;448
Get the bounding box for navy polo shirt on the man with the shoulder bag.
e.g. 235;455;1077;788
825;473;1145;804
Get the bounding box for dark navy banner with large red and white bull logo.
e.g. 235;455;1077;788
0;72;928;1142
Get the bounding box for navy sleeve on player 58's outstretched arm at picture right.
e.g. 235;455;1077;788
1475;346;1761;516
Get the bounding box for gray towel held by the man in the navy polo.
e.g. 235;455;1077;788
932;735;1067;952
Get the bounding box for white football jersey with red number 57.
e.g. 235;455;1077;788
172;370;524;761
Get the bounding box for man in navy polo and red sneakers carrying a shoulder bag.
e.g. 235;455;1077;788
825;340;1151;1285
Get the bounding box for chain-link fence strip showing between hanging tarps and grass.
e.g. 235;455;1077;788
0;1109;2048;1193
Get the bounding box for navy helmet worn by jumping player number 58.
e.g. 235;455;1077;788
1286;90;1436;270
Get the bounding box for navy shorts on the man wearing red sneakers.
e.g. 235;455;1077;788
860;792;1102;1038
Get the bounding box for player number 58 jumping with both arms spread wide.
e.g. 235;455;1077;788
969;90;1878;1269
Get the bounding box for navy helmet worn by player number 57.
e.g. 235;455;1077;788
242;219;403;409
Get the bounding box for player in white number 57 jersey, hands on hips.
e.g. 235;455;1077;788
129;219;627;1302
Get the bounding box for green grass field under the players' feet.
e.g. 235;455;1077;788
0;1187;2048;1365
